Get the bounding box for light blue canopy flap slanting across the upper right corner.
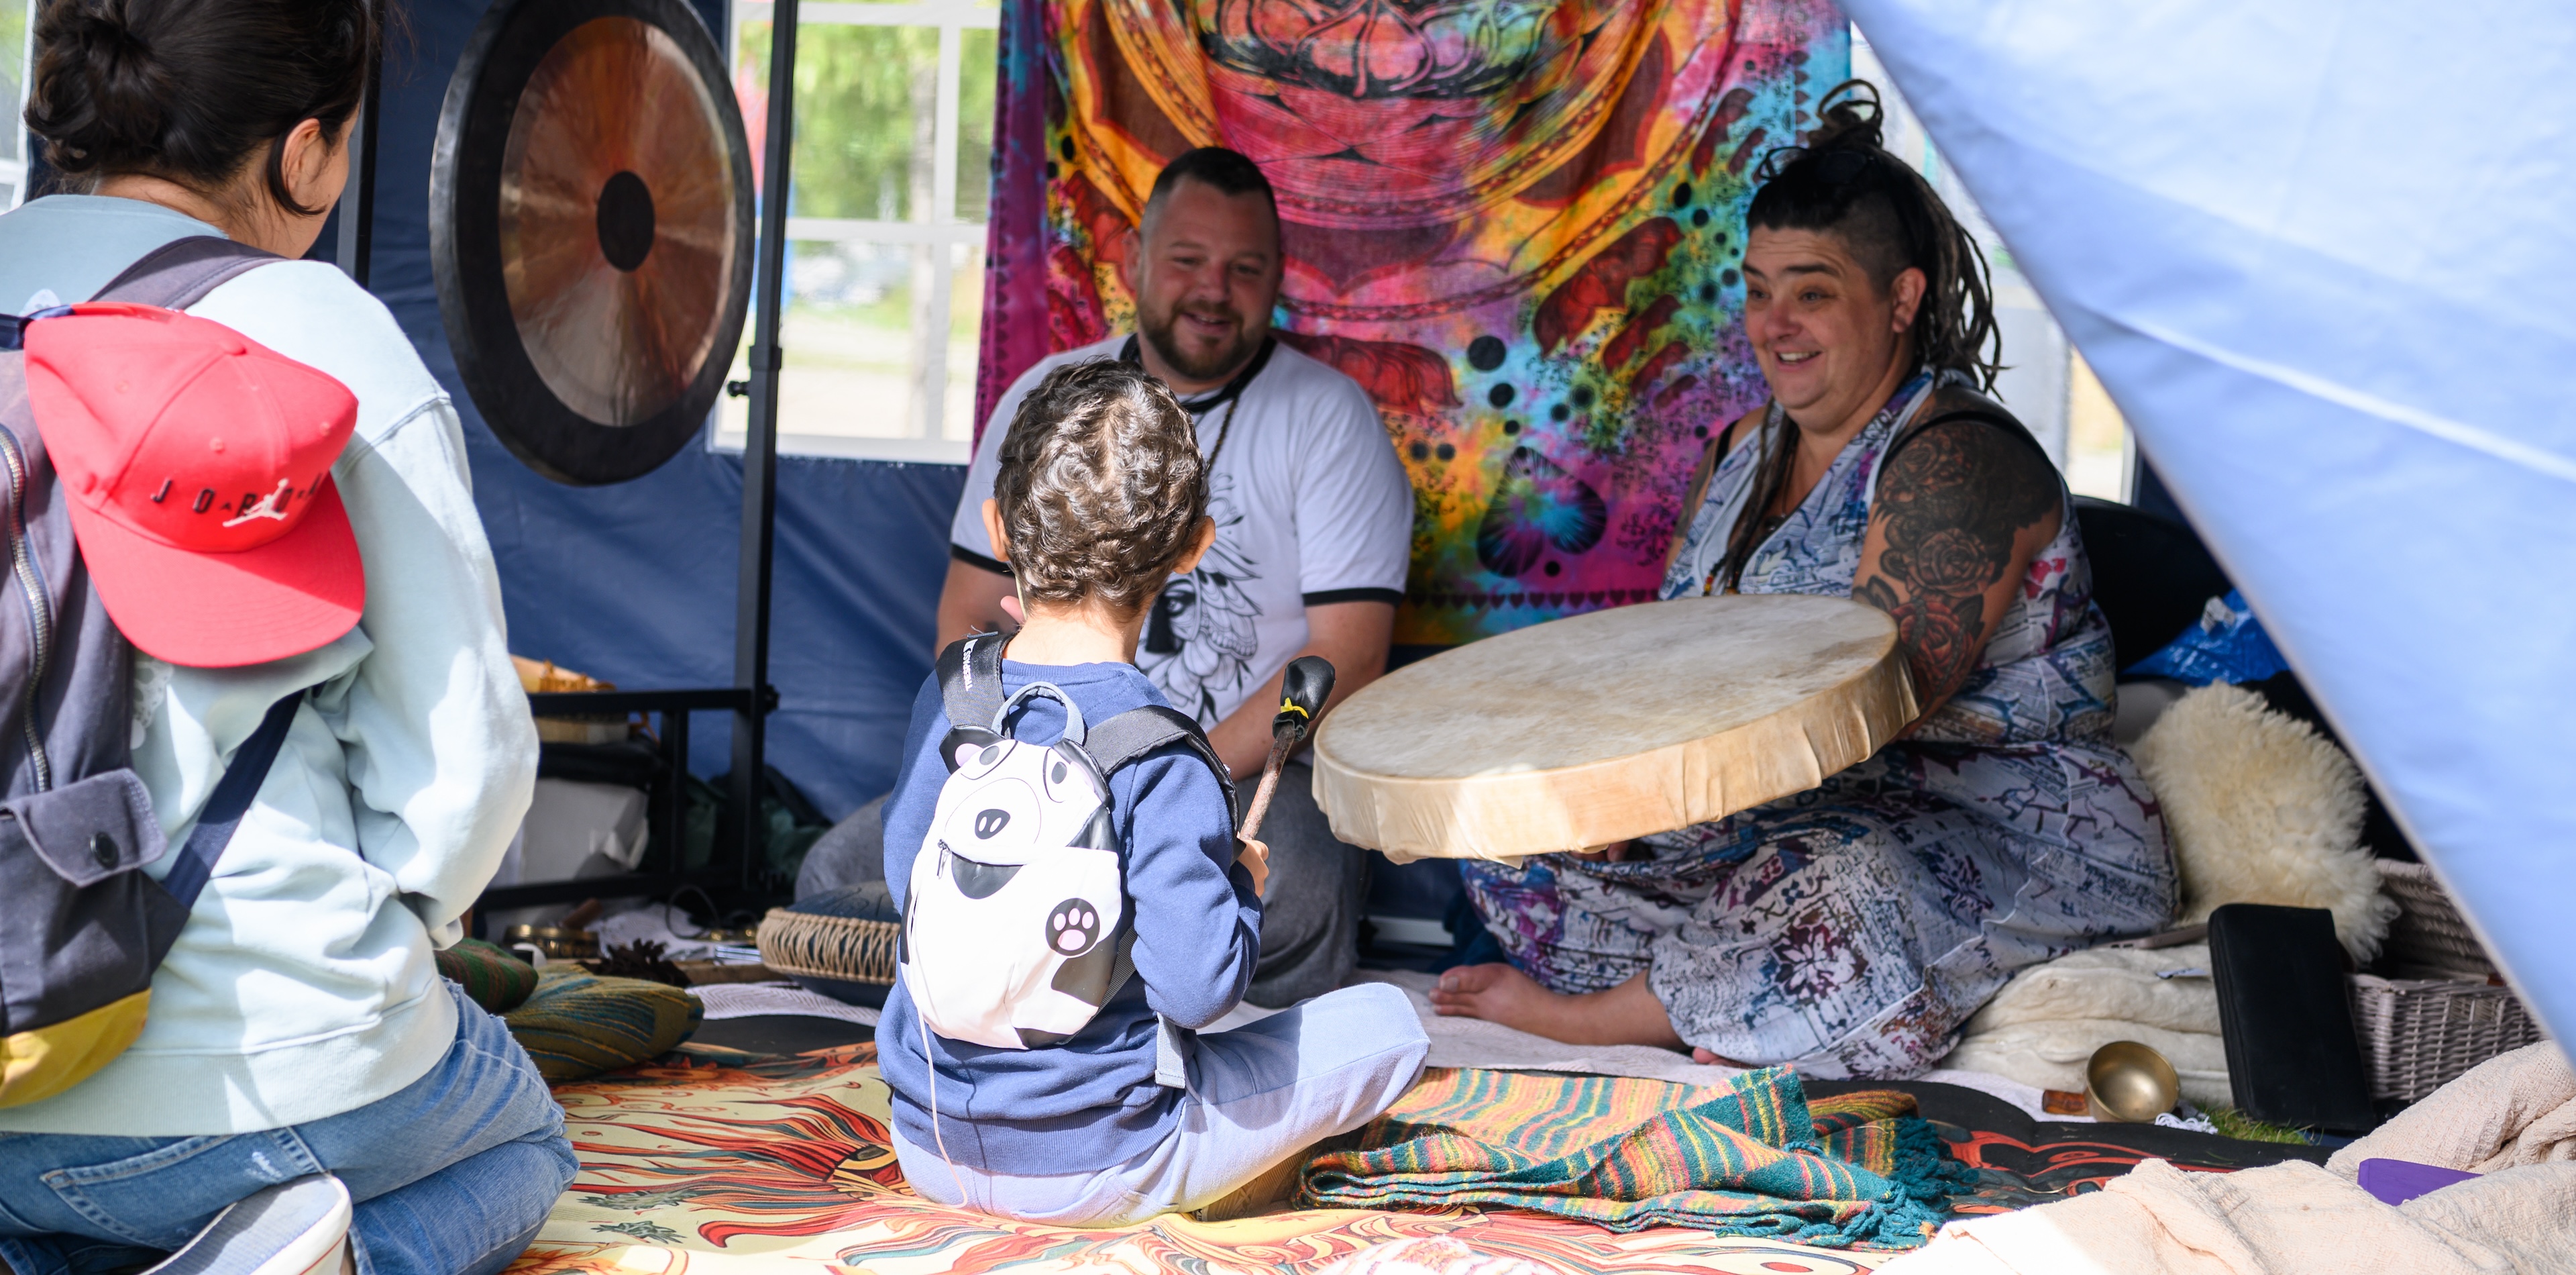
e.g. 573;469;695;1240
1844;0;2576;1041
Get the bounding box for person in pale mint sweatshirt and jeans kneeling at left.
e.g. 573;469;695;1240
0;0;574;1275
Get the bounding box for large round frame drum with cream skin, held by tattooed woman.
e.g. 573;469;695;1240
1313;595;1917;863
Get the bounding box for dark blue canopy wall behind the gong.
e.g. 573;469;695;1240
368;0;963;817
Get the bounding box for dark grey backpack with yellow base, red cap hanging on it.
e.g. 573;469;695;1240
0;237;301;1108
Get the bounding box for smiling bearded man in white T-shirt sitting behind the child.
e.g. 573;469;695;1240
798;147;1414;1005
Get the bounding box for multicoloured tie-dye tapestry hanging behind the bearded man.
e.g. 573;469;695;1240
979;0;1849;644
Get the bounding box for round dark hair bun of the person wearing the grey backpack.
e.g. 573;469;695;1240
25;0;180;172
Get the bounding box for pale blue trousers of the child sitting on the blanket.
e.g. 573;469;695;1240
894;984;1432;1226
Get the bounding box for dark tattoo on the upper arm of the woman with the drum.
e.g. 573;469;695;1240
1852;420;2058;711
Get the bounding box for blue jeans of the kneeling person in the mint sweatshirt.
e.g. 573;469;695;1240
0;984;574;1275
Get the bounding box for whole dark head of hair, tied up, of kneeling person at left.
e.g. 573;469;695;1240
25;0;381;214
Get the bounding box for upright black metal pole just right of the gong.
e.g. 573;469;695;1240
734;0;796;886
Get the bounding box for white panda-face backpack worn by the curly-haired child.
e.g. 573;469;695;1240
902;633;1234;1048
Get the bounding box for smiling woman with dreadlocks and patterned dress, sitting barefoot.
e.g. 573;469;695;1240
1432;85;2174;1076
